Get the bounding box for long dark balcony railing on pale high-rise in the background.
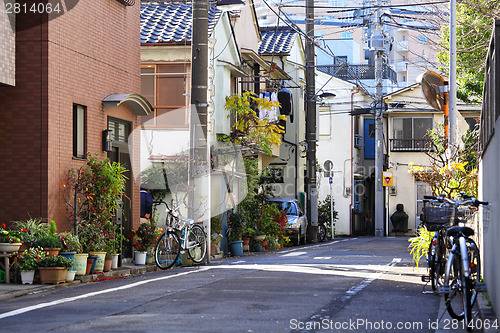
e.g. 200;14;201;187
316;64;398;83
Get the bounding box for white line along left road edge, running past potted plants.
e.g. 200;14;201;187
0;267;213;319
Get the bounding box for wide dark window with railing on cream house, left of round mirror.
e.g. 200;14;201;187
391;117;433;151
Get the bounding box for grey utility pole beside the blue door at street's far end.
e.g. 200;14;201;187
370;0;387;237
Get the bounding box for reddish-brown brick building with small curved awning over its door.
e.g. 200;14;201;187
0;0;150;254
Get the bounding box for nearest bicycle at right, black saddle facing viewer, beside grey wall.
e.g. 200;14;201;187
434;194;488;331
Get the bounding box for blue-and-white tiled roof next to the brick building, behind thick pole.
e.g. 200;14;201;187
141;1;221;43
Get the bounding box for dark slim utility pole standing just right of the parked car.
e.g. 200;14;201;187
305;0;318;243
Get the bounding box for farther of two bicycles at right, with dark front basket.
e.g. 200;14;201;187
420;195;458;291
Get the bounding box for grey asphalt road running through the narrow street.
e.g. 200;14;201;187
0;238;476;332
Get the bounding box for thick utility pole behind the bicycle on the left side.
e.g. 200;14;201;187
188;0;210;262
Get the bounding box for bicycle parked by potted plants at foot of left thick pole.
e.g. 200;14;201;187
153;200;207;269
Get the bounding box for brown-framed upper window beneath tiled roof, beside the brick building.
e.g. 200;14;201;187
141;64;191;128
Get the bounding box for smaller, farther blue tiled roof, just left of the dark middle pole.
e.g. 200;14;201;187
259;26;297;54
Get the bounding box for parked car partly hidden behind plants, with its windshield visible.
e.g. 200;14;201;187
269;198;307;245
